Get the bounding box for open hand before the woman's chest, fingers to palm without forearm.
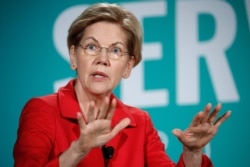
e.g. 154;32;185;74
74;98;130;153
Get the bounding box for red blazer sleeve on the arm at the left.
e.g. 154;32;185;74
13;99;59;167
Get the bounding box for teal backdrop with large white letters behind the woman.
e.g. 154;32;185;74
0;0;250;167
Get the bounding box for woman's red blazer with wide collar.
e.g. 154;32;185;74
13;80;212;167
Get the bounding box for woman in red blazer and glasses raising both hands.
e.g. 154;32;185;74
14;3;230;167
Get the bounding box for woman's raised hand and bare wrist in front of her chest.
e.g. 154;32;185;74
59;98;130;167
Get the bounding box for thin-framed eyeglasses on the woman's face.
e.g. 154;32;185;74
79;44;129;60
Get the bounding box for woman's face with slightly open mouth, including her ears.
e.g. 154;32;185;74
70;21;134;95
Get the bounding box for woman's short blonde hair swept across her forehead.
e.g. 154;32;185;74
67;3;143;66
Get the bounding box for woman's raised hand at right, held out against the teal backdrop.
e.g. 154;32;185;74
172;104;231;152
